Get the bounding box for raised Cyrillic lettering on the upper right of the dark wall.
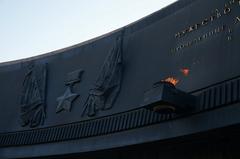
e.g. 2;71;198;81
171;0;240;53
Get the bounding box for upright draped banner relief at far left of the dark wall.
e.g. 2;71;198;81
20;63;47;127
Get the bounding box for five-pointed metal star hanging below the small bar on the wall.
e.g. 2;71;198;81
56;87;79;113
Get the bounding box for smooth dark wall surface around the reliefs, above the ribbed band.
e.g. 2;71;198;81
0;0;240;157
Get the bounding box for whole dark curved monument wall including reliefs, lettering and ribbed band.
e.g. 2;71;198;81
0;0;240;158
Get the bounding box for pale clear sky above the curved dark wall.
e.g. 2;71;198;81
0;0;176;62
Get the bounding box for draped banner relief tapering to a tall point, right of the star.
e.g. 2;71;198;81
82;32;123;117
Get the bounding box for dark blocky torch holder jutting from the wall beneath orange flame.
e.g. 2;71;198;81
142;81;196;113
